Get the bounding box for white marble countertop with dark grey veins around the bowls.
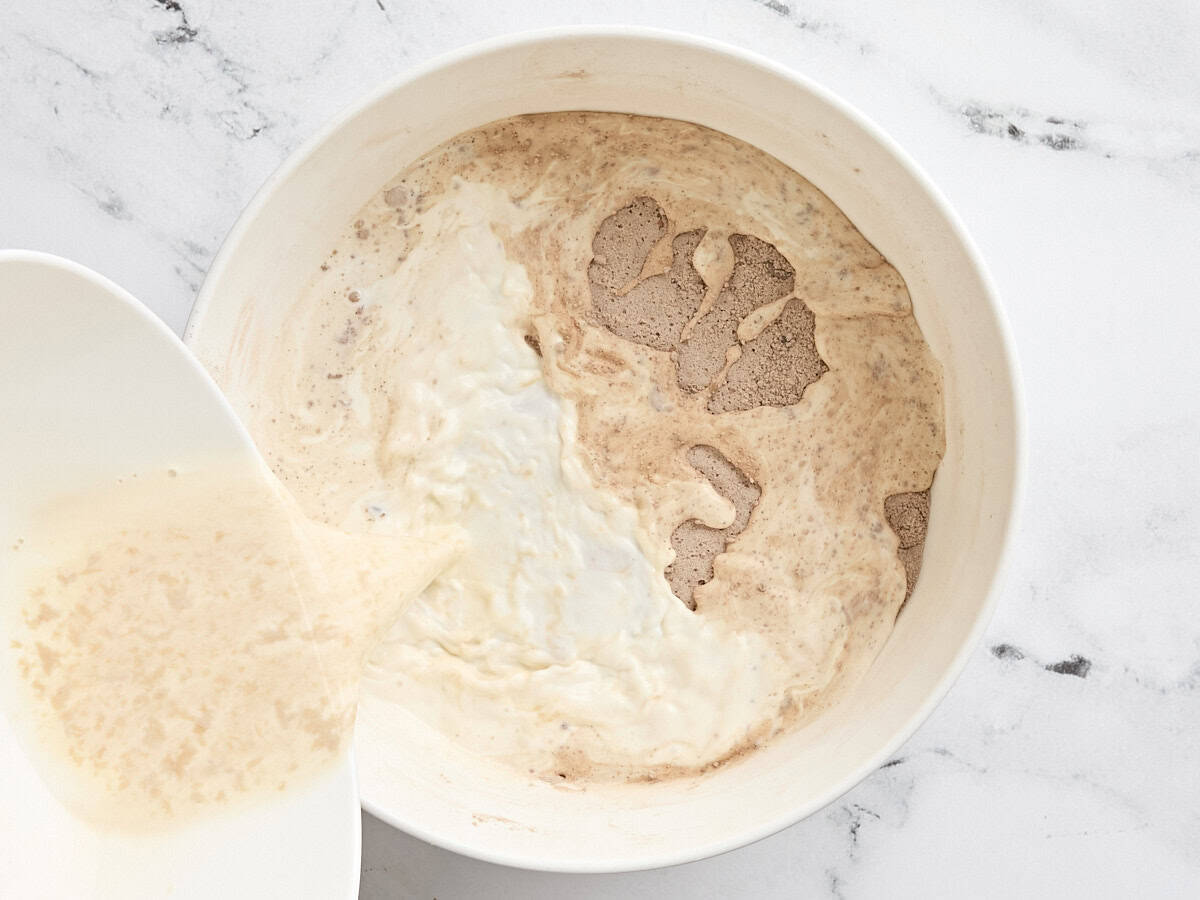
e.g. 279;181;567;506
0;0;1200;900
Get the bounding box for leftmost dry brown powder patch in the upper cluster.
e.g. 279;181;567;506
588;197;706;350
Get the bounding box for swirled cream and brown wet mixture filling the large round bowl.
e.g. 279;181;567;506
242;113;944;782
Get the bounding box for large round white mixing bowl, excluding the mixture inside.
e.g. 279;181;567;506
186;28;1022;871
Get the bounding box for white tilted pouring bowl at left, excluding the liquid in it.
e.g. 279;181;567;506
0;251;360;898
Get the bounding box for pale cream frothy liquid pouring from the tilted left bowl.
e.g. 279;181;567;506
4;460;456;830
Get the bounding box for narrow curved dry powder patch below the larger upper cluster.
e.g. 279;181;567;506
666;444;762;610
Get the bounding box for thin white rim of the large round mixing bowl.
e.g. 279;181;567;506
184;25;1027;874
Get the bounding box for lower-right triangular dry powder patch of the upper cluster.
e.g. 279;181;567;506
708;298;829;413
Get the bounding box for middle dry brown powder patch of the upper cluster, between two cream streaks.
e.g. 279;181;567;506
676;234;796;393
